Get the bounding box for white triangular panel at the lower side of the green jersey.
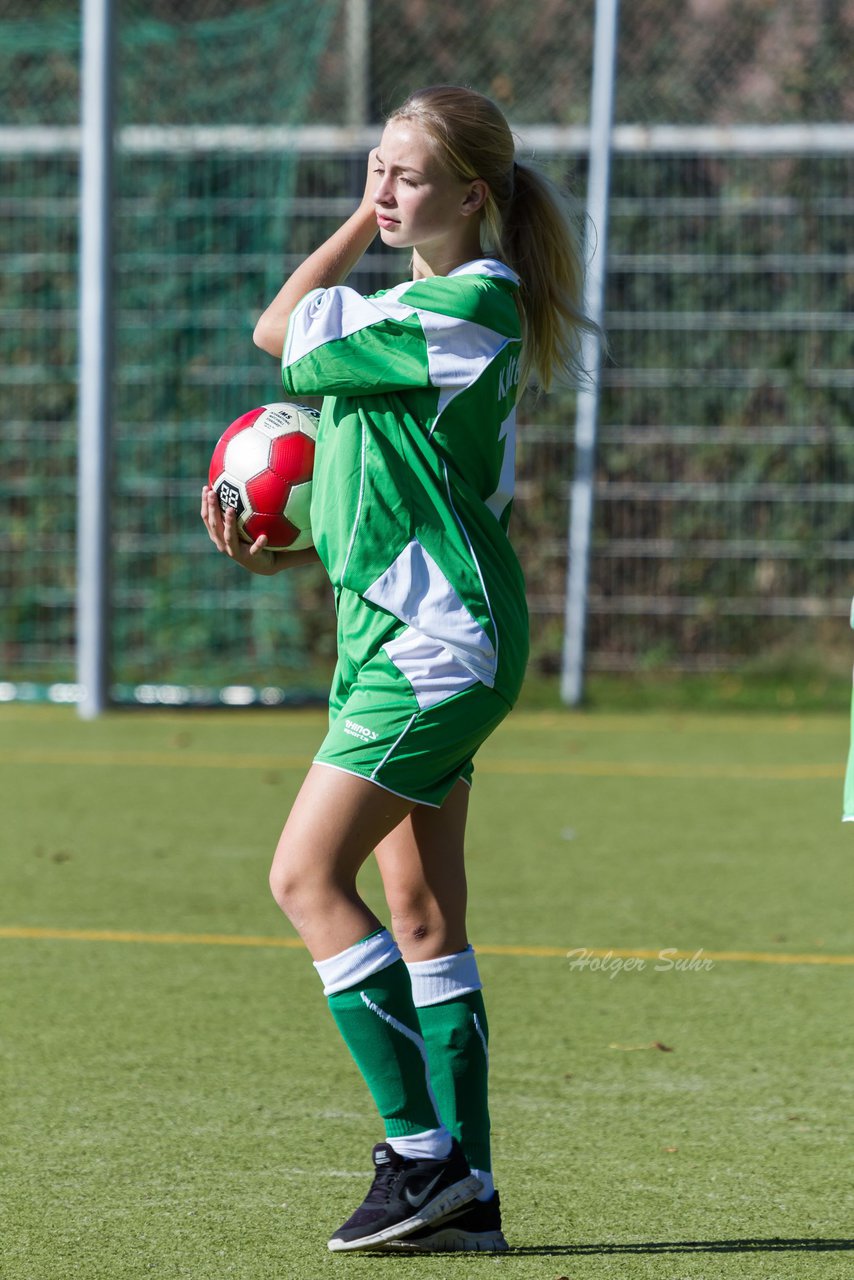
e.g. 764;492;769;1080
362;538;497;689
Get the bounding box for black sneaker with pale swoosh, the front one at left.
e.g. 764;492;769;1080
329;1138;481;1251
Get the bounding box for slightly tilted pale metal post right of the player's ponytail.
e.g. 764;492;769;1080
561;0;620;707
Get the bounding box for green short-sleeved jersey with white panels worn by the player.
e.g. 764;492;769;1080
282;260;528;707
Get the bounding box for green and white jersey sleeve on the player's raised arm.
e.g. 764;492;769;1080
282;285;430;396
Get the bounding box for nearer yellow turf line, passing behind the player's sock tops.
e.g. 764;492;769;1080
0;924;854;965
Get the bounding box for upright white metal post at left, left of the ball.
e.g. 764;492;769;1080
77;0;115;719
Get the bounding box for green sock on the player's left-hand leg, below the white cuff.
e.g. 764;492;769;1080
318;940;440;1138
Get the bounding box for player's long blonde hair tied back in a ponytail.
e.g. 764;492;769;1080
389;84;599;390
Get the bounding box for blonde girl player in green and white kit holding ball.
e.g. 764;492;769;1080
201;86;599;1251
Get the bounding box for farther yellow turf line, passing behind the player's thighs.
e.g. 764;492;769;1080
0;748;845;782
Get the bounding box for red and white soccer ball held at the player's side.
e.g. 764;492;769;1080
209;404;320;552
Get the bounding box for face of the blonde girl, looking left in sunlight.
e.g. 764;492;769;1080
374;119;485;256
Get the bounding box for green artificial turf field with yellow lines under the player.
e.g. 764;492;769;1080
0;705;854;1280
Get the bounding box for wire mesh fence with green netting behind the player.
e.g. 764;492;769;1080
0;0;854;696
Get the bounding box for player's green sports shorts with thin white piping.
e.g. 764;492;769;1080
315;649;510;808
